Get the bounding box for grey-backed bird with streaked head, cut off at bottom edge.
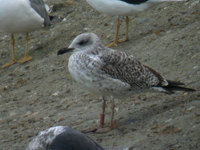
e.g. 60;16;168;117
26;126;104;150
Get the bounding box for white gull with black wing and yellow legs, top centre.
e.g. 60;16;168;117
86;0;185;47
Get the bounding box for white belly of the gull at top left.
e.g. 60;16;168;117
0;0;44;33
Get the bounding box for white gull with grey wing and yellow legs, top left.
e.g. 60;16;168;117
0;0;50;68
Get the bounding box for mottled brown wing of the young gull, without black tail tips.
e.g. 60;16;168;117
99;51;165;89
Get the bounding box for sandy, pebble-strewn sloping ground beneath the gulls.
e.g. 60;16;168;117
0;0;200;150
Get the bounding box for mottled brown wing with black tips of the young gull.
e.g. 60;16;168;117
95;50;195;94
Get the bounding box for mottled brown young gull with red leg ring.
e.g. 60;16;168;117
58;33;194;132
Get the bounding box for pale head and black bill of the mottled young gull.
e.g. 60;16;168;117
57;33;101;55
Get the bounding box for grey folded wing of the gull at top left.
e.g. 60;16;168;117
29;0;50;26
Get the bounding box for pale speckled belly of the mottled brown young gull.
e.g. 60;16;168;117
68;59;130;96
